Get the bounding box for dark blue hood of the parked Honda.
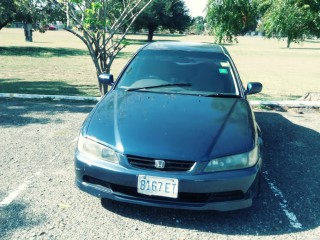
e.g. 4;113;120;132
85;90;254;161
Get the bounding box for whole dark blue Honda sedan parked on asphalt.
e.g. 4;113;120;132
75;42;262;211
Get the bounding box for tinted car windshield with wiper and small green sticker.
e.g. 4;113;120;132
117;50;238;95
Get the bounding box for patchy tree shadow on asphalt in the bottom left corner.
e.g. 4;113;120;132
0;201;45;239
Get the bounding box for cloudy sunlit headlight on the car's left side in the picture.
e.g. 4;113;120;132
78;134;119;163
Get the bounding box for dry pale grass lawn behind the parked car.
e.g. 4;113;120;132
0;28;320;100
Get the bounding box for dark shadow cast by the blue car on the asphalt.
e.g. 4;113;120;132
102;112;320;236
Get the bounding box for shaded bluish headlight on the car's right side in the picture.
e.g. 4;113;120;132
204;145;259;172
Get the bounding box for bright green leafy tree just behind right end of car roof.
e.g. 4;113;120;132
207;0;257;43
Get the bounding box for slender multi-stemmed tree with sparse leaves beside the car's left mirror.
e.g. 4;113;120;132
56;0;152;92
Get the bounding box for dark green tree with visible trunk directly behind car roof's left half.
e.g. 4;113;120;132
133;0;191;42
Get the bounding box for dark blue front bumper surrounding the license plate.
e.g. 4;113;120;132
75;153;261;211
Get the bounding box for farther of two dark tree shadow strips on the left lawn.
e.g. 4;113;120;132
0;47;89;58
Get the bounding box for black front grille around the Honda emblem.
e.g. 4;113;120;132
127;155;195;172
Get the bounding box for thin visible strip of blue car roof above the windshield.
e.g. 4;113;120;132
143;41;228;54
